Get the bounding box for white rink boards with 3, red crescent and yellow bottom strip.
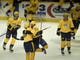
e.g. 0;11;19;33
0;2;76;22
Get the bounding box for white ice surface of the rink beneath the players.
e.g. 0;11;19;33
0;20;80;60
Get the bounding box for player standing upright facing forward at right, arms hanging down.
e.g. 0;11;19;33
57;13;74;55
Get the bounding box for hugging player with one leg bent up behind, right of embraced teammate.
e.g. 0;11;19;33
31;21;48;54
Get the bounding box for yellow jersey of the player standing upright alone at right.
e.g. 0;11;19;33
58;19;74;33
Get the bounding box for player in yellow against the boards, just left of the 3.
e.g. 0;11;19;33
24;0;39;17
